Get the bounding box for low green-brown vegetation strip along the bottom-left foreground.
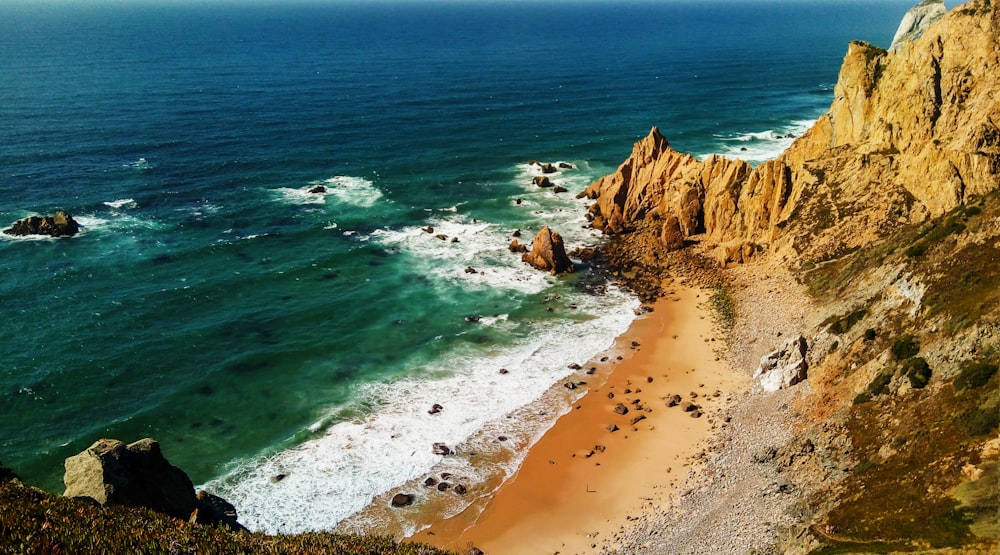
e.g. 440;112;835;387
0;478;448;555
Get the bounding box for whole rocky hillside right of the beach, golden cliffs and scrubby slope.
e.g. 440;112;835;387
583;0;1000;553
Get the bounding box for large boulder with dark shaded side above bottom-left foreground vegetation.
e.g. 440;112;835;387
63;438;242;528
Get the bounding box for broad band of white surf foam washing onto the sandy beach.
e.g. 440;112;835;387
205;284;636;533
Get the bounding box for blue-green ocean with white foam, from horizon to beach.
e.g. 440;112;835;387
0;0;912;532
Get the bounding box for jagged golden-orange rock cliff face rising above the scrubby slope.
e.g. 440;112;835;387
582;0;1000;270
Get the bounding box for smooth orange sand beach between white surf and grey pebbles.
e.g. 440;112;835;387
412;283;748;554
